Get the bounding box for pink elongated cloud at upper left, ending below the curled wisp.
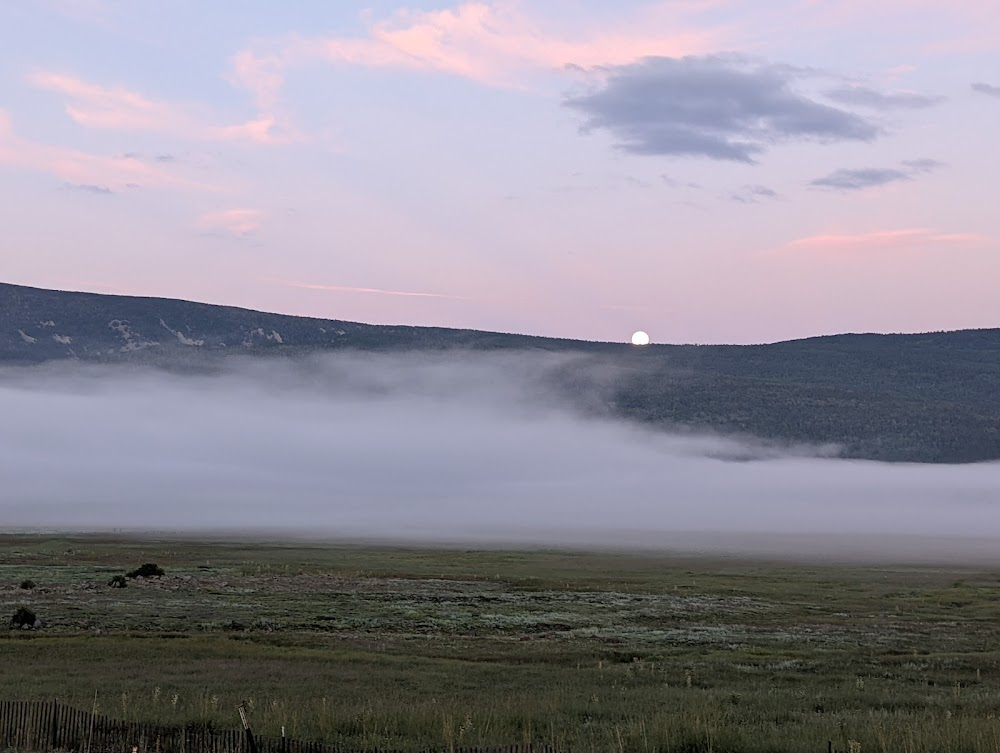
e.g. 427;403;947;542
28;72;298;144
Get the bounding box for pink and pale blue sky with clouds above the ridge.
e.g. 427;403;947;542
0;0;1000;343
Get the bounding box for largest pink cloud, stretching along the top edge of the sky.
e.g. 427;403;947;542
232;0;719;98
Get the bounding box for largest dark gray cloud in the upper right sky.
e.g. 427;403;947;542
564;56;879;162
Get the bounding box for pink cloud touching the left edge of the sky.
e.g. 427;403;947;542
0;111;214;190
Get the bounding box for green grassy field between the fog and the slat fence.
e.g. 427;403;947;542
0;535;1000;753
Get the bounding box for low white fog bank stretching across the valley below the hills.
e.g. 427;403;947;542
0;354;1000;556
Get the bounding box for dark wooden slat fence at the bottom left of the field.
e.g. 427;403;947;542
0;701;555;753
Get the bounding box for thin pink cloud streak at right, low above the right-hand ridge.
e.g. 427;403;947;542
778;228;996;259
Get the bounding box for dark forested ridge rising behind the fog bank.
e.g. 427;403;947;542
0;283;1000;463
